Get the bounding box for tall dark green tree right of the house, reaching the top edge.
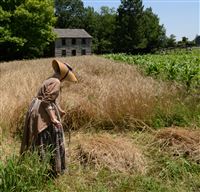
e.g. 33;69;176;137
115;0;147;53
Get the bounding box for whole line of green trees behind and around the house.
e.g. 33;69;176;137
0;0;197;60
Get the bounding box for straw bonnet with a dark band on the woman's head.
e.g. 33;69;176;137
52;59;78;82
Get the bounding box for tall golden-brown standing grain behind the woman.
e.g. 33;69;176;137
0;56;173;134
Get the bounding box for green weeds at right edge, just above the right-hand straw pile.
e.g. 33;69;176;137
147;95;200;128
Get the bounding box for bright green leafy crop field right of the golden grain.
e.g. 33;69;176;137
105;50;200;92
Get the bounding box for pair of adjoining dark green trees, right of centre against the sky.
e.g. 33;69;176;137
115;0;165;53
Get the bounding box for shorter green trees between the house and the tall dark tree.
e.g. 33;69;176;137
83;6;116;54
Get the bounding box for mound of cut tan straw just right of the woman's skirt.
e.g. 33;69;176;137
72;134;146;173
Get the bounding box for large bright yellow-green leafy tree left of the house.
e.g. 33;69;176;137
0;0;55;60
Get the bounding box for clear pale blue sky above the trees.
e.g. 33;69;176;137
83;0;200;41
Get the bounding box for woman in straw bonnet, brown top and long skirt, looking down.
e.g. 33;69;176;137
20;60;77;175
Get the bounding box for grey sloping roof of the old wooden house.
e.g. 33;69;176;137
54;28;92;38
